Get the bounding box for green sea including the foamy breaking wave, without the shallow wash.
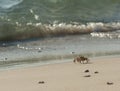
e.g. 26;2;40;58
0;0;120;41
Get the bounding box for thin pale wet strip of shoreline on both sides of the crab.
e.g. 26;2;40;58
0;55;120;71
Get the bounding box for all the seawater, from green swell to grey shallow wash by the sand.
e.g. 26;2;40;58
0;0;120;67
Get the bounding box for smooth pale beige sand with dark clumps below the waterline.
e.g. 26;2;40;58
0;57;120;91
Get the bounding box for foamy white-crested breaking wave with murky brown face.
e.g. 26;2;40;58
0;22;120;40
